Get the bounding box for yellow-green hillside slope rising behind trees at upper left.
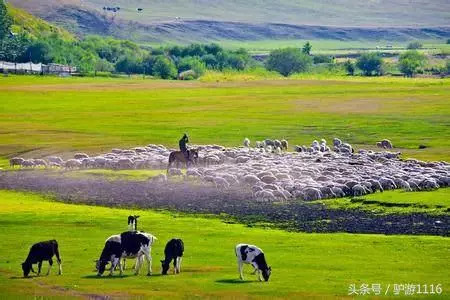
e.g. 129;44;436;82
8;5;75;41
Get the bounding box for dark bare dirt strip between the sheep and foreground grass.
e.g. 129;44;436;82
0;170;450;236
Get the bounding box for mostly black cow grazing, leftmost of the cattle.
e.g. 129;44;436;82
22;240;62;277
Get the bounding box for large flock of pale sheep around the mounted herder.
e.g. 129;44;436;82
11;138;450;201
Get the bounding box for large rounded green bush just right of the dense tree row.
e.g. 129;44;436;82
266;48;312;76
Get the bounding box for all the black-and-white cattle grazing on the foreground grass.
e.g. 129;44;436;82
22;216;272;281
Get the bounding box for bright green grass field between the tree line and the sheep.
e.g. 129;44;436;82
0;76;450;164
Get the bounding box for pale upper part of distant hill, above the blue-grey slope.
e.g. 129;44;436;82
11;0;450;27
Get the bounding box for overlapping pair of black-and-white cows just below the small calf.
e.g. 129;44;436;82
97;231;156;276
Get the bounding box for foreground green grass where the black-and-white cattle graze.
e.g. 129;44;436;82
0;191;450;299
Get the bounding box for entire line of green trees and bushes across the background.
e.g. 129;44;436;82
0;2;449;80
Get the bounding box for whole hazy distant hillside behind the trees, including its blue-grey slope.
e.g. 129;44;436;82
10;0;450;43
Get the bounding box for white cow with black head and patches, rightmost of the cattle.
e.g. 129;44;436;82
235;244;272;281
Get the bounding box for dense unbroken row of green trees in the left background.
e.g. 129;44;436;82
0;1;253;79
